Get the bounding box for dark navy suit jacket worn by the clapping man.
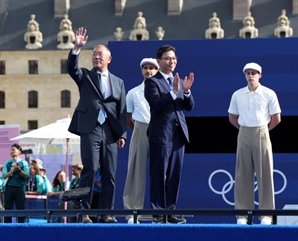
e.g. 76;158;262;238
145;72;194;144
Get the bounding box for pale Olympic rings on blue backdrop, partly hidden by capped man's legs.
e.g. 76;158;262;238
208;169;287;206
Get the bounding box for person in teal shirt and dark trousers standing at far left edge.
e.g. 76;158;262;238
2;144;29;223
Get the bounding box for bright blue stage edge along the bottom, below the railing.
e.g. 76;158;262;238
0;223;298;241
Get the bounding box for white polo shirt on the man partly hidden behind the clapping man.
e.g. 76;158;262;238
126;81;150;124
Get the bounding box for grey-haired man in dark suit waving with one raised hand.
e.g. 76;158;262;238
67;28;127;223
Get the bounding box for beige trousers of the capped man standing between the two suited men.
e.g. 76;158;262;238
123;121;149;219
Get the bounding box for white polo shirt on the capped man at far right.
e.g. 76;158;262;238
228;84;281;127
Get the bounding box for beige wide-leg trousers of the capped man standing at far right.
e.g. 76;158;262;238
234;126;275;219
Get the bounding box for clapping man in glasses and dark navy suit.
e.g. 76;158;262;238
145;45;194;223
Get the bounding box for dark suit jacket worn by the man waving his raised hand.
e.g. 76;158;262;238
67;52;127;140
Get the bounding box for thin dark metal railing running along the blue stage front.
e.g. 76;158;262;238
0;209;298;224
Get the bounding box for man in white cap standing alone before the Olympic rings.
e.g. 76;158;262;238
228;63;281;225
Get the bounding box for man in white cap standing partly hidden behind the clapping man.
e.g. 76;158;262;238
123;58;159;223
